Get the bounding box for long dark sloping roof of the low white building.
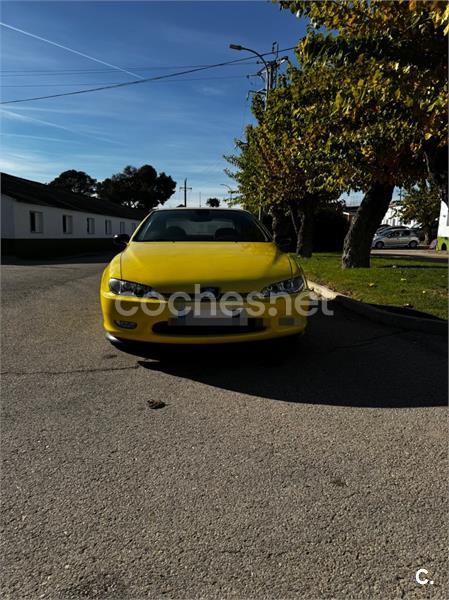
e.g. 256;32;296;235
1;173;147;221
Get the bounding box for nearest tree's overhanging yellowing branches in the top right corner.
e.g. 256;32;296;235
279;0;449;204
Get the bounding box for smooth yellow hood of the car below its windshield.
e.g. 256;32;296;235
120;242;299;293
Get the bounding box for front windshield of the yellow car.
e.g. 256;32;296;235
133;208;270;242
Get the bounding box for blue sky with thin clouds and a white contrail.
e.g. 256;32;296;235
0;1;305;204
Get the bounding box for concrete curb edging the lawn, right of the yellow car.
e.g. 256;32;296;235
308;281;448;337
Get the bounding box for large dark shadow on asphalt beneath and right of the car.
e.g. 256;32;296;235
117;303;447;408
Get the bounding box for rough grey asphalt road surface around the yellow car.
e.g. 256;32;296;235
1;254;448;600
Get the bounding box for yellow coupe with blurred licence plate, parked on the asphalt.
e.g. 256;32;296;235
100;208;309;344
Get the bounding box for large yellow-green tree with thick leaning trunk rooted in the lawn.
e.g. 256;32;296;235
272;0;447;267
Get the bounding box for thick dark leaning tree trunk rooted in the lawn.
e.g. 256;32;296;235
342;183;394;269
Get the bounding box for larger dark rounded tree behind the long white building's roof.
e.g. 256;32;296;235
98;165;176;210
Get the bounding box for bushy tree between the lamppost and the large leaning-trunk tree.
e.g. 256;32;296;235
225;80;339;256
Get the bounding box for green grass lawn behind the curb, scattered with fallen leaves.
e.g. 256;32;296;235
300;253;448;319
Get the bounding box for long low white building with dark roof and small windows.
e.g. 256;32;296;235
1;173;146;256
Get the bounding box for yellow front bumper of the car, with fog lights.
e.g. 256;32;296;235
101;290;310;344
